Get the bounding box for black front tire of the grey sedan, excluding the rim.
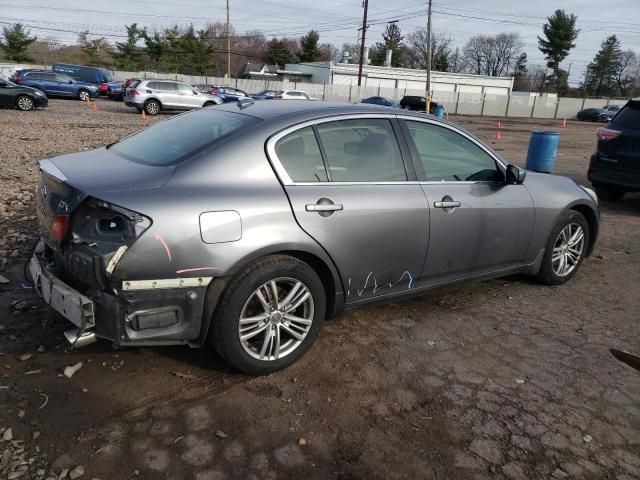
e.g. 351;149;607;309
536;210;590;285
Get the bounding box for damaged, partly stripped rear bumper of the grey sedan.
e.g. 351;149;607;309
29;249;219;346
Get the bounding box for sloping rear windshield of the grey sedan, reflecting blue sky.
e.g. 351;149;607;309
109;108;259;166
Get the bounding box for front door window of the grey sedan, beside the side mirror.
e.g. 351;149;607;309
406;121;502;182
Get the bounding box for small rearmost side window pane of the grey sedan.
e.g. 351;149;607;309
276;127;327;182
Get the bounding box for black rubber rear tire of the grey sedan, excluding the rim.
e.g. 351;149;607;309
210;255;326;375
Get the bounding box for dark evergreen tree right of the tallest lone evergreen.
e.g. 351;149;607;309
586;35;622;97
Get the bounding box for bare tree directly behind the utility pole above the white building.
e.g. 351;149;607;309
404;27;452;72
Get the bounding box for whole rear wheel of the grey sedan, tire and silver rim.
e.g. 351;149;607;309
211;255;326;375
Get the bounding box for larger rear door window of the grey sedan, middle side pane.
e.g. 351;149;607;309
317;118;407;182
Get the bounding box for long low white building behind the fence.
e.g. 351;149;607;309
285;62;513;95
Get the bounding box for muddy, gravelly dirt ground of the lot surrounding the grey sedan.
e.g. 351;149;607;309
0;100;640;480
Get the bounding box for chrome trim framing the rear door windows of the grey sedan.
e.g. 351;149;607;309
266;113;408;186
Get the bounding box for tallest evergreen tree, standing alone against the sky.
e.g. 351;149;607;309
538;10;580;91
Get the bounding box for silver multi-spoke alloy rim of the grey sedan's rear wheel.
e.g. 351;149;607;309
238;277;314;361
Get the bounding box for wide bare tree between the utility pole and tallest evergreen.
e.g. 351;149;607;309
462;32;524;77
